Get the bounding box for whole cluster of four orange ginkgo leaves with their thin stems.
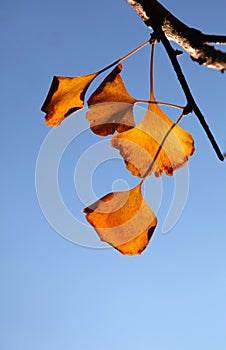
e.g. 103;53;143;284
42;40;194;255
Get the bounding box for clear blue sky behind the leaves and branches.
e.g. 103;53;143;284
0;0;226;350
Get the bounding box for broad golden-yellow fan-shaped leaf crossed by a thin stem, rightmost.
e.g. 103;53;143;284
111;104;194;177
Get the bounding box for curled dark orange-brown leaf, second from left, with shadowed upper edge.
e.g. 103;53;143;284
86;64;136;136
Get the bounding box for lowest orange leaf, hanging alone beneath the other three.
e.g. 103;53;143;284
83;184;157;255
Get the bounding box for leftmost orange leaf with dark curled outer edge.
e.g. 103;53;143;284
41;73;98;126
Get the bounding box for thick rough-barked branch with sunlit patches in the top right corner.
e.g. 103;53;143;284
126;0;226;72
